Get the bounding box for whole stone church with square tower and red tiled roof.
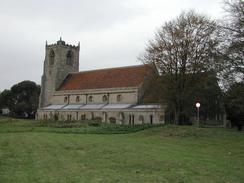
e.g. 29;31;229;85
36;38;165;125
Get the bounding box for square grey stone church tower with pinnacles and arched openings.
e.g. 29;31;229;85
39;38;80;108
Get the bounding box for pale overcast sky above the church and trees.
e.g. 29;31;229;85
0;0;223;91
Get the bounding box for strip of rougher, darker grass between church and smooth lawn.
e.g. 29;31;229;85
0;117;162;134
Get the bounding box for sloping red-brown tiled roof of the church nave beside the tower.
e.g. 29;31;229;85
58;65;150;91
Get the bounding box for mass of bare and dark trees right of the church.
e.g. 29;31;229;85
139;0;244;128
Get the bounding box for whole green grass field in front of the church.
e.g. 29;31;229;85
0;118;244;183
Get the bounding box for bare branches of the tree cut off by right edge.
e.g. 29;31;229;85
222;0;244;85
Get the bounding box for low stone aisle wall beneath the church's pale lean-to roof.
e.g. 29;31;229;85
37;108;165;125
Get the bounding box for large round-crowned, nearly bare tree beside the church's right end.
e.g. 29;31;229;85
139;11;219;124
